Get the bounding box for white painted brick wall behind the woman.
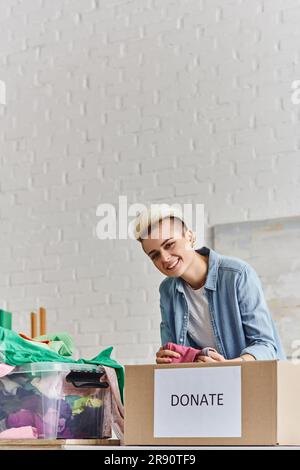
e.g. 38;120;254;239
0;0;300;363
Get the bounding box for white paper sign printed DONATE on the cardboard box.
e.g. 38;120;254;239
154;366;242;437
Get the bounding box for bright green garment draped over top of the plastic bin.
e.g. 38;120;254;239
0;326;124;401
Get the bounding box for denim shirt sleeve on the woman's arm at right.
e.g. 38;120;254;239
237;264;277;360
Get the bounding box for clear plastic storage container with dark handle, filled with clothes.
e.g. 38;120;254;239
0;362;110;439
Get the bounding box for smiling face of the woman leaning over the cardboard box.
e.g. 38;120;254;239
142;219;195;277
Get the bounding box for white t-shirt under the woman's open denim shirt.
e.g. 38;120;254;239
184;282;216;348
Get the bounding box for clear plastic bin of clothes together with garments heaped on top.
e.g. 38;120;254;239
0;327;124;443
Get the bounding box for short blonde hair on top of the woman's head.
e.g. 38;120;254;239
133;204;187;242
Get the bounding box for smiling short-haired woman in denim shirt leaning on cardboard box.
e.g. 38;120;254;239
135;204;285;364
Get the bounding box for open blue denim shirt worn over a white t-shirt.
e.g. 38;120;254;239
159;247;286;360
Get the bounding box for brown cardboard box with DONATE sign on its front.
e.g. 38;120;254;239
125;361;300;446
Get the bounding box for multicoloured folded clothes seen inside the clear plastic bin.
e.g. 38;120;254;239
0;366;105;439
